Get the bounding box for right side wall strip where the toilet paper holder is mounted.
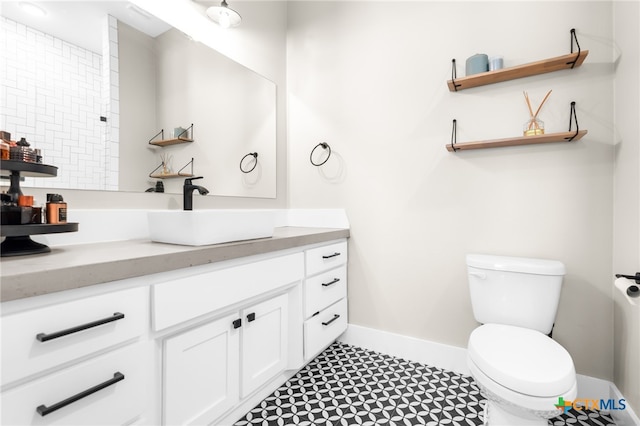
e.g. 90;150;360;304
613;1;640;413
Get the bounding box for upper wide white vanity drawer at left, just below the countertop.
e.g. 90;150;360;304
0;287;149;385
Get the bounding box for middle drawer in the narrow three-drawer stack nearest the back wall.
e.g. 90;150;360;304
304;265;347;318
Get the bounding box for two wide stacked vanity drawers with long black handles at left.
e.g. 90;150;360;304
0;287;152;425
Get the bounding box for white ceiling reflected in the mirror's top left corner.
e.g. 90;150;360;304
0;0;171;53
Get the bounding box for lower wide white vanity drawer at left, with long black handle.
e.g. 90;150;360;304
1;343;153;425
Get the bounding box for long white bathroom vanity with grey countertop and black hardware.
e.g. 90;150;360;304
0;227;349;425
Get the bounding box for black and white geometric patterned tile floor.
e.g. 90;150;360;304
235;342;615;426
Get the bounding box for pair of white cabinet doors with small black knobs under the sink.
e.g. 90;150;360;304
163;294;289;425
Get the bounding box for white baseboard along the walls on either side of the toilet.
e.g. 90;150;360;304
338;324;640;426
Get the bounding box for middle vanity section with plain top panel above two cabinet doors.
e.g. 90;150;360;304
158;252;304;425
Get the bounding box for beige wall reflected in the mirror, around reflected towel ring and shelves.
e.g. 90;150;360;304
152;30;276;198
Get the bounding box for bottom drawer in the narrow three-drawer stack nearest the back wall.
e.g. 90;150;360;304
304;299;347;360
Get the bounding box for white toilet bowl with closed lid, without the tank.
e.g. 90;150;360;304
467;324;577;426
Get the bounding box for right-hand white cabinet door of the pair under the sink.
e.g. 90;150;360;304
242;294;289;398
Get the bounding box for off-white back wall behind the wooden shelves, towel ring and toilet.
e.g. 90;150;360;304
287;2;614;379
